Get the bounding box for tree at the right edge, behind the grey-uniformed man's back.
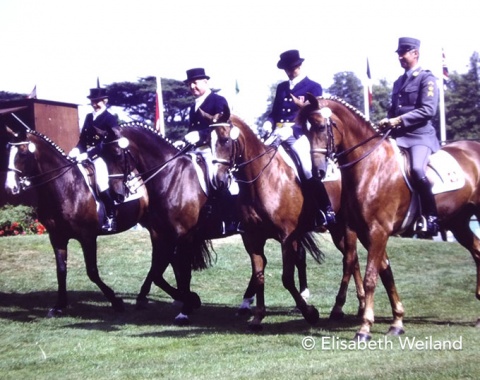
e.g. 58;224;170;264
445;52;480;140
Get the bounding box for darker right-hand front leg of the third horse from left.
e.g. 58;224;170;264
282;242;319;324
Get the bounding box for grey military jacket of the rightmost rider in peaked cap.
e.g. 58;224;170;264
388;68;440;152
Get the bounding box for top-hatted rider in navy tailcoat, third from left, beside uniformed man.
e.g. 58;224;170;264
263;50;335;226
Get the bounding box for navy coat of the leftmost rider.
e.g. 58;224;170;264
77;110;118;156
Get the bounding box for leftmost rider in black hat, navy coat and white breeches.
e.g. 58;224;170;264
70;87;118;232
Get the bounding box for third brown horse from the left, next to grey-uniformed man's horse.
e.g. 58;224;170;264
211;115;363;328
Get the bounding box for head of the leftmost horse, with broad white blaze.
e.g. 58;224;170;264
5;128;37;195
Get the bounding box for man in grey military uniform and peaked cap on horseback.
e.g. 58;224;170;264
379;37;440;236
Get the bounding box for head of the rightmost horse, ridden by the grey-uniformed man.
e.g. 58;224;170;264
297;94;335;178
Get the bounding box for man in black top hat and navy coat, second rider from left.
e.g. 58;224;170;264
184;68;241;235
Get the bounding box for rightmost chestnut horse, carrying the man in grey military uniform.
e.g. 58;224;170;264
297;95;480;341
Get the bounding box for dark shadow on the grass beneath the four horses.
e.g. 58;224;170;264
0;291;474;338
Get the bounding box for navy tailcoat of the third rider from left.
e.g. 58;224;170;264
268;77;322;126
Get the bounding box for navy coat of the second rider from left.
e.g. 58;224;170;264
188;92;230;141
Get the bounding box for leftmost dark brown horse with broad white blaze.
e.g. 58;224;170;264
5;129;148;317
